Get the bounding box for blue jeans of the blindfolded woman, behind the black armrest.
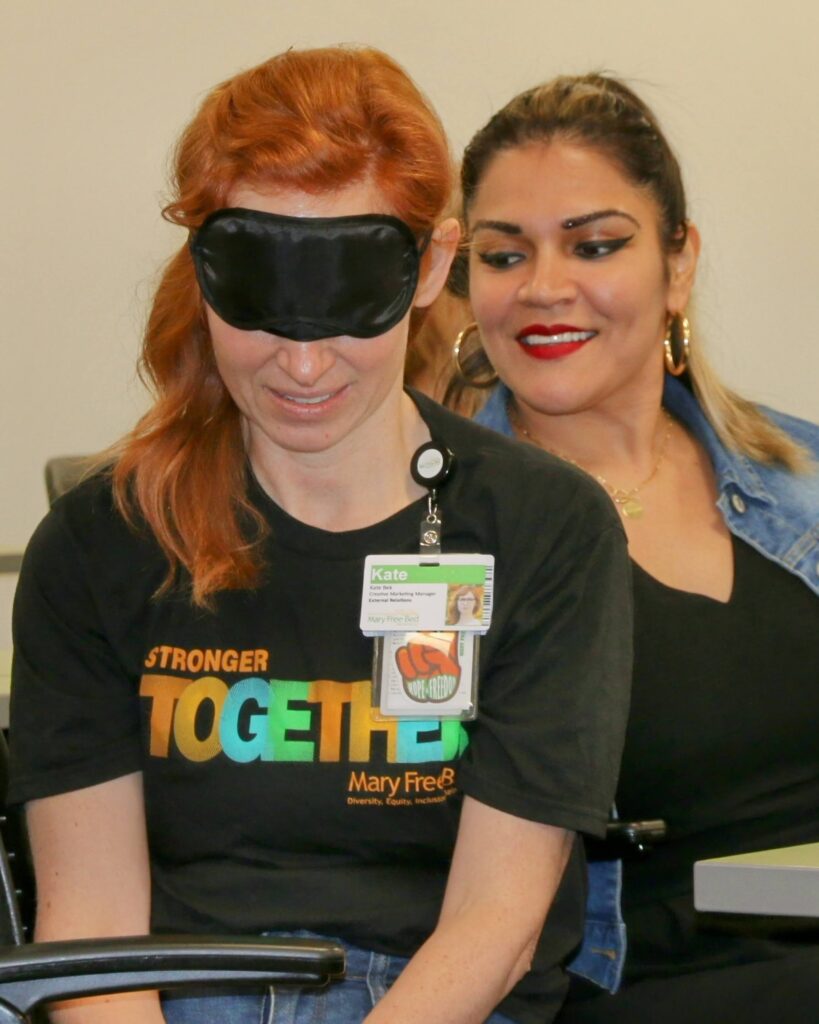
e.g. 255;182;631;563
162;932;514;1024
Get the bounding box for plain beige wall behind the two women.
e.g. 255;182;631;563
0;0;819;643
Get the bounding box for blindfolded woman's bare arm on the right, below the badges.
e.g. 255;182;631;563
367;797;573;1024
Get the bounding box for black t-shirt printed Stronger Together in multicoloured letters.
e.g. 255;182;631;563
11;397;631;1021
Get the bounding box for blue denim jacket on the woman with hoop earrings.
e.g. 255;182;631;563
476;375;819;992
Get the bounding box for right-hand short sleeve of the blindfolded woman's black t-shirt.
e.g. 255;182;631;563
459;483;633;836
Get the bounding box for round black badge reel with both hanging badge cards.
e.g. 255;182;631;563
361;441;493;721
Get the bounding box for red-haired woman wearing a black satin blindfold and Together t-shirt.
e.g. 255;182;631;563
11;48;630;1024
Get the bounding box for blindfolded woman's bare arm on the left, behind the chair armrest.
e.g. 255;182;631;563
27;773;164;1024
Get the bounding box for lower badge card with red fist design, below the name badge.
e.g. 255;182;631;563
373;630;480;721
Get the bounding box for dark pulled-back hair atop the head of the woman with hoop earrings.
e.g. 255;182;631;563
461;73;687;252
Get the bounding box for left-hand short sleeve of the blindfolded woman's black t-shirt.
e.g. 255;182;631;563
8;499;140;803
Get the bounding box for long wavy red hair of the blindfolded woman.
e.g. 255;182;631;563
113;48;451;606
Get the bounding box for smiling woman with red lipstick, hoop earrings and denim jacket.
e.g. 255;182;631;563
456;74;819;1024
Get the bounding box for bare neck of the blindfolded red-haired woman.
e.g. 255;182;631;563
249;392;430;532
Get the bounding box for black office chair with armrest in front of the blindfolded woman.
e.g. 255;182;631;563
0;733;344;1024
